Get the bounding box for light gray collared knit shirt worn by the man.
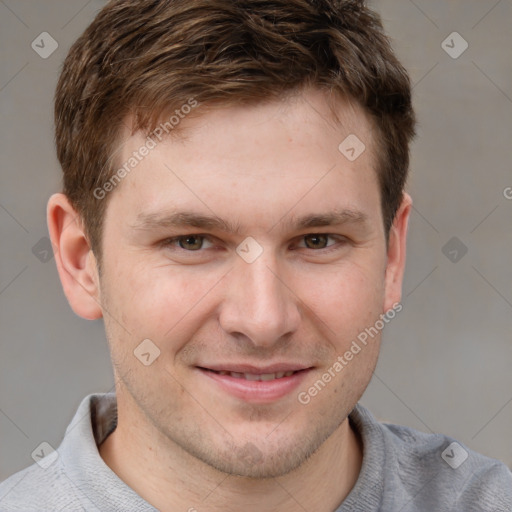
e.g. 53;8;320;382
0;393;512;512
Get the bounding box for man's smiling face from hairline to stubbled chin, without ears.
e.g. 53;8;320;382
97;87;399;477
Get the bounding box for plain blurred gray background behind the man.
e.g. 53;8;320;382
0;0;512;479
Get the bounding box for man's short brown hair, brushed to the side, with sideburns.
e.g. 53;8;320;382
55;0;415;260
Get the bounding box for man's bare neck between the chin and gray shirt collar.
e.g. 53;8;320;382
99;395;362;512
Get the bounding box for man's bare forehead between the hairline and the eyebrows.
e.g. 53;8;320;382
106;91;379;232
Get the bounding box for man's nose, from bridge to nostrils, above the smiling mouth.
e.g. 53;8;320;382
219;252;301;348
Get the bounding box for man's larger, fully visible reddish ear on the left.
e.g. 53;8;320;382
47;194;103;320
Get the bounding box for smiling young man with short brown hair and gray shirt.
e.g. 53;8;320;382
0;0;512;512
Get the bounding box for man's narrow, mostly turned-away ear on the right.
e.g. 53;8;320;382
384;192;412;311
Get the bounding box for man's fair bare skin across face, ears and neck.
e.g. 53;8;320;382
48;89;412;512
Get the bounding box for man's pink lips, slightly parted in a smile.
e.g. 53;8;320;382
196;364;313;404
